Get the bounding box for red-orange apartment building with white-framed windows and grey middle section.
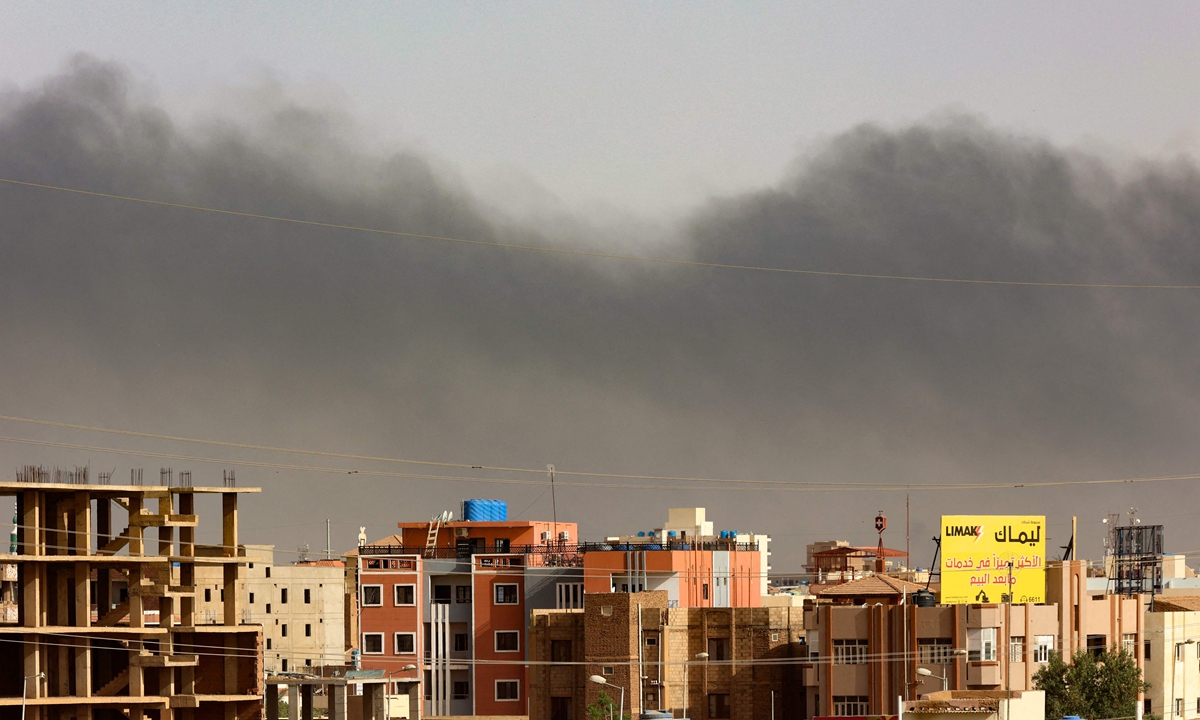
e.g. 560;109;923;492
347;506;583;716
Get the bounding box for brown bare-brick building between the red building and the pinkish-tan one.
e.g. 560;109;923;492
529;590;806;720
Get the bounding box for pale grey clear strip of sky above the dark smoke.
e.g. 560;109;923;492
7;0;1200;215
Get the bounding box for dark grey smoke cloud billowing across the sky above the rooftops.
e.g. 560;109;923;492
0;56;1200;561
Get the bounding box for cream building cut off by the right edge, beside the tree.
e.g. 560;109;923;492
1142;596;1200;720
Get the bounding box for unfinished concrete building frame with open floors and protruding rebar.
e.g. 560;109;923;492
0;467;263;720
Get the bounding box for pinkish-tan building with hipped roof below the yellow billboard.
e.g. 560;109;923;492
804;560;1144;716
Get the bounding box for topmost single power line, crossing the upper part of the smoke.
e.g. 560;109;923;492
0;178;1200;290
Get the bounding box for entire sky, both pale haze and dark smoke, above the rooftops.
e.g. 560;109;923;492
0;2;1200;570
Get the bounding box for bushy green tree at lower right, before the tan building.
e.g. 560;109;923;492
1033;649;1150;719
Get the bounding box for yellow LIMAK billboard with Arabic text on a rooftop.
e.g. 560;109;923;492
941;515;1046;604
